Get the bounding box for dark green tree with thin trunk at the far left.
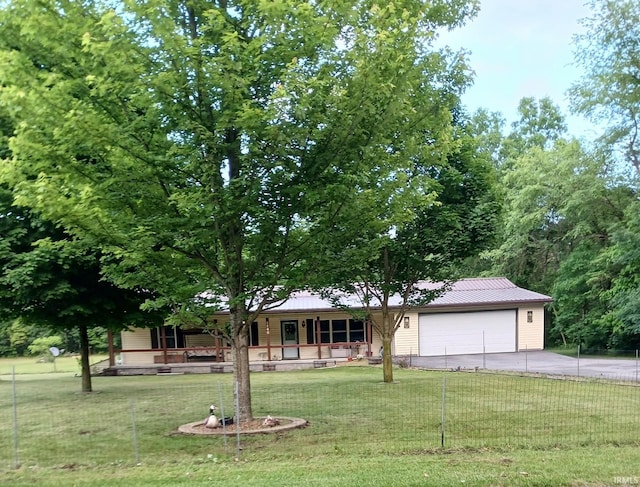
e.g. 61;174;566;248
0;185;162;392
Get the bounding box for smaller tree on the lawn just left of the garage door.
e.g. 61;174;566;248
316;112;500;382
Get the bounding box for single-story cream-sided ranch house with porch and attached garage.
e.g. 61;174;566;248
110;278;552;373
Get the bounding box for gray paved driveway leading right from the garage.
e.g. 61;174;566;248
410;351;640;382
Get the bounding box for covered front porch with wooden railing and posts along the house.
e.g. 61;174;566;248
109;313;379;371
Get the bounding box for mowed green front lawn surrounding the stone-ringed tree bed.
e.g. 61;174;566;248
0;366;640;486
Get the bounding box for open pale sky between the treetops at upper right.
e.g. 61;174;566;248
441;0;593;136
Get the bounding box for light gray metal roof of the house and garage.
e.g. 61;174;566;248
258;277;553;313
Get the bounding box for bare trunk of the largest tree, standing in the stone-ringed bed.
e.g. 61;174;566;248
231;310;253;422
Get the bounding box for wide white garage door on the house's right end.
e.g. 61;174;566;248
419;309;516;357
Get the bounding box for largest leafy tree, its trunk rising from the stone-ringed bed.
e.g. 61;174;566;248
0;0;478;420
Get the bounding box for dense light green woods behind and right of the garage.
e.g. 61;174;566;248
486;92;640;349
